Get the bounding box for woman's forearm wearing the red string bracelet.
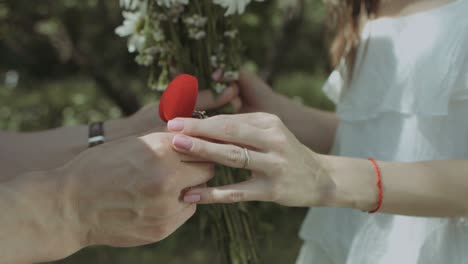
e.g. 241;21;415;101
323;156;468;217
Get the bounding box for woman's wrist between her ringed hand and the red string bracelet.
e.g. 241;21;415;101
321;155;378;212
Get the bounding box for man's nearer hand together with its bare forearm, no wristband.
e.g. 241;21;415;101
0;133;213;263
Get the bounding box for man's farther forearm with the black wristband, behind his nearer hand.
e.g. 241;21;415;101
0;119;142;182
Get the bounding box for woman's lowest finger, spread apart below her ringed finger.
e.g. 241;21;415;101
184;179;271;204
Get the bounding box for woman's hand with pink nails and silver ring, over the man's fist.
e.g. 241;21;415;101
168;113;335;206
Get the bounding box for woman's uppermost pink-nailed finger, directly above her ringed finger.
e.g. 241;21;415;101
167;115;269;150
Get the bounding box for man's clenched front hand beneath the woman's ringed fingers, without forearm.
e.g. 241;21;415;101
63;133;213;247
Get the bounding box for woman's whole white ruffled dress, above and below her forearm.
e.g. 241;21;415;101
297;0;468;264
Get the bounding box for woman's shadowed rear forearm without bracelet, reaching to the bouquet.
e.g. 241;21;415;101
272;95;338;154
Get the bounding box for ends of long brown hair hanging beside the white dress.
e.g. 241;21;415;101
324;0;380;66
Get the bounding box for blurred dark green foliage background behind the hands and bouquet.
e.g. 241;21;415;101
0;0;333;264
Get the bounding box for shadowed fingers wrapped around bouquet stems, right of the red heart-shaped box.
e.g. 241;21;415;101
196;84;239;110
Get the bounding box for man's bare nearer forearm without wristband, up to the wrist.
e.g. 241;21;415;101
0;170;81;264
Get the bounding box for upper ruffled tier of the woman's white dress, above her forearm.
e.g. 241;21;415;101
324;0;468;120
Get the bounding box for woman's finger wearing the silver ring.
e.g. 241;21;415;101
172;135;268;171
